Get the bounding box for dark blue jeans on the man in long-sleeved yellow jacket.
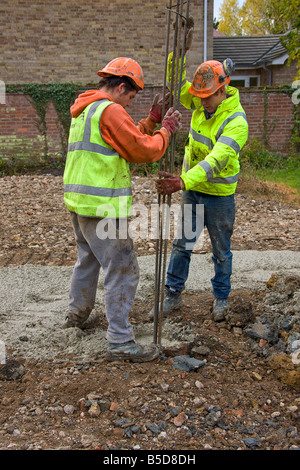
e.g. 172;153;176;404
166;191;235;299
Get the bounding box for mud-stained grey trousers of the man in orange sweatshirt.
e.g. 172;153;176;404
67;213;139;343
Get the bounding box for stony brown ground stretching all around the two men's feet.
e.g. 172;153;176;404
0;174;300;454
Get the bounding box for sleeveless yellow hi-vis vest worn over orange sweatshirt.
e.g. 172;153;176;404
64;99;132;218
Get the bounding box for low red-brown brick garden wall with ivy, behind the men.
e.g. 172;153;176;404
0;86;294;158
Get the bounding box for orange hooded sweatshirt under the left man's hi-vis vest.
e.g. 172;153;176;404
71;90;170;163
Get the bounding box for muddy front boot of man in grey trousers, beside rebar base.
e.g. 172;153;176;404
106;341;159;362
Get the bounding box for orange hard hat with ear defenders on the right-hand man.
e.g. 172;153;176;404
189;59;234;98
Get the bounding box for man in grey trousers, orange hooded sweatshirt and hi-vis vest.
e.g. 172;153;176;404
64;57;180;362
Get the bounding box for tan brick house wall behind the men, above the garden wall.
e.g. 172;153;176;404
0;0;213;85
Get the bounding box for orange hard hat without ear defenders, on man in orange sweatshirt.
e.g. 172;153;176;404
98;57;144;90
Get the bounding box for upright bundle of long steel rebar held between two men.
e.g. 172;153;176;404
154;0;189;345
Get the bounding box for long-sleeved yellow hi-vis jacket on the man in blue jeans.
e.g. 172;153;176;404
167;54;248;196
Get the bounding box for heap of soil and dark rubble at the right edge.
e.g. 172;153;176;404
226;274;300;388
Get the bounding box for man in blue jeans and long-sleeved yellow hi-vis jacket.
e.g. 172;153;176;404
152;22;248;321
